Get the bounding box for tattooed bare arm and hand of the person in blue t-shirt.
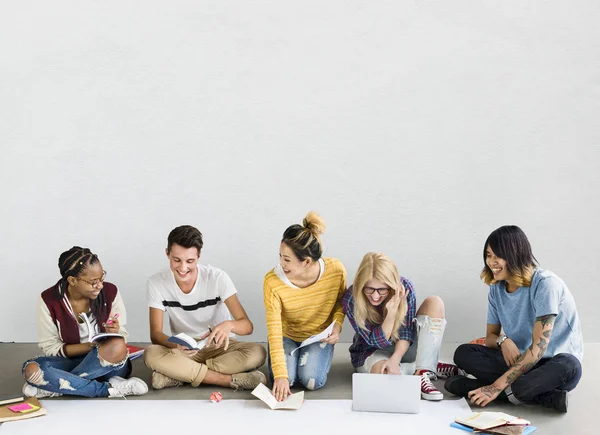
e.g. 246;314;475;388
469;314;556;406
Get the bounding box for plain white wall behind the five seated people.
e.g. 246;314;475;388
0;0;600;342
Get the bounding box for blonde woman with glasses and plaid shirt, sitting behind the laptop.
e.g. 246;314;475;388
342;252;458;400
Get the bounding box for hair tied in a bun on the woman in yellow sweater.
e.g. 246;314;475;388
281;211;325;261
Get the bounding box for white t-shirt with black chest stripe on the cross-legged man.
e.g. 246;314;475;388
146;264;237;338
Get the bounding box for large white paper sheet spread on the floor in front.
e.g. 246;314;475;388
0;399;471;435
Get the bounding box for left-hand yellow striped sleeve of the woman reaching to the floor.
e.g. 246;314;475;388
263;274;288;379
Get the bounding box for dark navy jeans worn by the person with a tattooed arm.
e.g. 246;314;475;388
454;344;581;403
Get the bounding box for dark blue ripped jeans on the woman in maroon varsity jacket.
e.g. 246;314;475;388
23;347;131;397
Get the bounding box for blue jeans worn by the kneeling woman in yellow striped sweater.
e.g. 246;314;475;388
267;337;333;390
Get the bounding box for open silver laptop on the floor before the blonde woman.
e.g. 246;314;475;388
352;373;421;414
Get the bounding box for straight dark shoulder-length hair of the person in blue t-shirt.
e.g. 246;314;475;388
481;225;537;285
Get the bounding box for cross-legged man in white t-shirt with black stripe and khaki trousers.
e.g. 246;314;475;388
144;225;267;389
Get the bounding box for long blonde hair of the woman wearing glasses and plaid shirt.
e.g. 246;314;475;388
352;252;408;341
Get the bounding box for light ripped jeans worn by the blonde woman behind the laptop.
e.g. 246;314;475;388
356;314;447;375
